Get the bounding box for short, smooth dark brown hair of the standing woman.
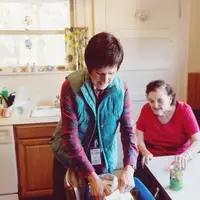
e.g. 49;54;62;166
85;32;124;72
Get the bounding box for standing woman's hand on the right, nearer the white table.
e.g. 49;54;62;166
118;165;135;193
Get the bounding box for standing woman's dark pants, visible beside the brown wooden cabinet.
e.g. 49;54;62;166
53;157;67;200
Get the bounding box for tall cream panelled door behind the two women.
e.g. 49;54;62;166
94;0;189;123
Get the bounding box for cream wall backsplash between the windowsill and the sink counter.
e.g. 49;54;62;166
0;72;68;104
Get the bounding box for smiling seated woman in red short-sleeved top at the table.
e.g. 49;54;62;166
136;80;200;168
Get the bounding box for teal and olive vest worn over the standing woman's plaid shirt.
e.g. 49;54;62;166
52;69;125;173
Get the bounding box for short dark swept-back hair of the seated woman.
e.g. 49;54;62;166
146;80;176;105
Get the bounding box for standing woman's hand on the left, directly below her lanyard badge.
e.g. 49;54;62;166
88;172;111;200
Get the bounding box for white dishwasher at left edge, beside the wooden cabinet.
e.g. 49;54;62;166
0;125;18;200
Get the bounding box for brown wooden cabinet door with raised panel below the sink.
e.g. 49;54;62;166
17;138;53;197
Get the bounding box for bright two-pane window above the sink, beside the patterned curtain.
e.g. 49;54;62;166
0;0;70;71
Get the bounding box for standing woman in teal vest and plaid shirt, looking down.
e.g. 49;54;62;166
52;32;154;200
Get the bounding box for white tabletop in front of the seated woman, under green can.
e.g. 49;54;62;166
147;154;200;200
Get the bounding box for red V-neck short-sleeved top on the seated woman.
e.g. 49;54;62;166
136;101;199;156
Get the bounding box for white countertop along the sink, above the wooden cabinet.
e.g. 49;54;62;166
0;115;60;126
